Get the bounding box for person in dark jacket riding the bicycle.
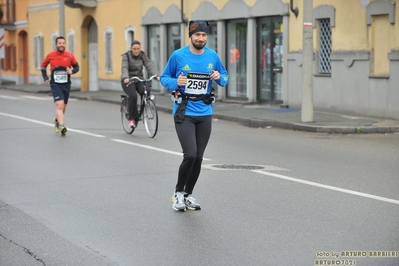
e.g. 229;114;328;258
121;41;159;128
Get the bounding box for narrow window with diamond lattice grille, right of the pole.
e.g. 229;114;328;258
318;19;332;74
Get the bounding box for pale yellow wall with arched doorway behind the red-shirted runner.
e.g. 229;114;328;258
29;0;142;80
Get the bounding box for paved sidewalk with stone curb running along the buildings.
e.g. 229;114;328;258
1;84;399;134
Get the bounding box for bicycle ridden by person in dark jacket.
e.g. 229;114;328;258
120;75;158;138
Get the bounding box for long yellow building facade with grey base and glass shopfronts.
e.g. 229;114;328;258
3;0;399;119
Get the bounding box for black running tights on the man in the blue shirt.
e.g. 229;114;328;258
175;115;212;194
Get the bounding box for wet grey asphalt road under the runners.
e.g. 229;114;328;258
0;90;399;266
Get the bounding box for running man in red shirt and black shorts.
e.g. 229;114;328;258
40;36;79;136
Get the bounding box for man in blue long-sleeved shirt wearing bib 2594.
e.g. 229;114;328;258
161;20;228;211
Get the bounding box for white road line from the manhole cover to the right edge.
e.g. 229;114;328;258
251;170;399;205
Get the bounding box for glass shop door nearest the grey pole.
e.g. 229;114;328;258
257;17;283;104
